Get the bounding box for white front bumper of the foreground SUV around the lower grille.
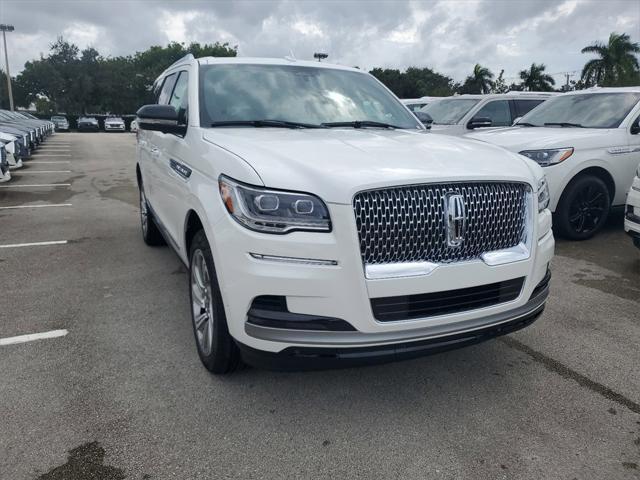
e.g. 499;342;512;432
210;198;555;361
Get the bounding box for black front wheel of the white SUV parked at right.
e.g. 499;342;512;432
553;175;611;240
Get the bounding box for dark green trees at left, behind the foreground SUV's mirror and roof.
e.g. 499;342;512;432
11;37;237;114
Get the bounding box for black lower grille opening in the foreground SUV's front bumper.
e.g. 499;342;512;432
371;277;524;322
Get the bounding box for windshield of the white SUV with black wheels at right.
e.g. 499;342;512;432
518;92;640;128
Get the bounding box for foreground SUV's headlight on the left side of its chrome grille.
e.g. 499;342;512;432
218;175;331;233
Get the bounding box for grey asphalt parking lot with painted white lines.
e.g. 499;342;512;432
0;133;640;480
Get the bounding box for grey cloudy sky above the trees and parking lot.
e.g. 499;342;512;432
0;0;640;81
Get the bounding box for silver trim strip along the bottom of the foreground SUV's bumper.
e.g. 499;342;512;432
244;287;549;347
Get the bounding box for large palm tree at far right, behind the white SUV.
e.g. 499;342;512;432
582;32;640;86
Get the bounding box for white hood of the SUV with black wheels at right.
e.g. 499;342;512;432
465;127;618;152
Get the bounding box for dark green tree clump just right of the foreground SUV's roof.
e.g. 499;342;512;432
369;67;456;98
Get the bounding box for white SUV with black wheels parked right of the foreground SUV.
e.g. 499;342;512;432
471;87;640;240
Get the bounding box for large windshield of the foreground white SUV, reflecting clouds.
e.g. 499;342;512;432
200;64;422;129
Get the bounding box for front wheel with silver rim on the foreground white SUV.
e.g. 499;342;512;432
189;230;241;375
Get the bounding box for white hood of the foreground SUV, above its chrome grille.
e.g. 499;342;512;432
203;128;535;204
